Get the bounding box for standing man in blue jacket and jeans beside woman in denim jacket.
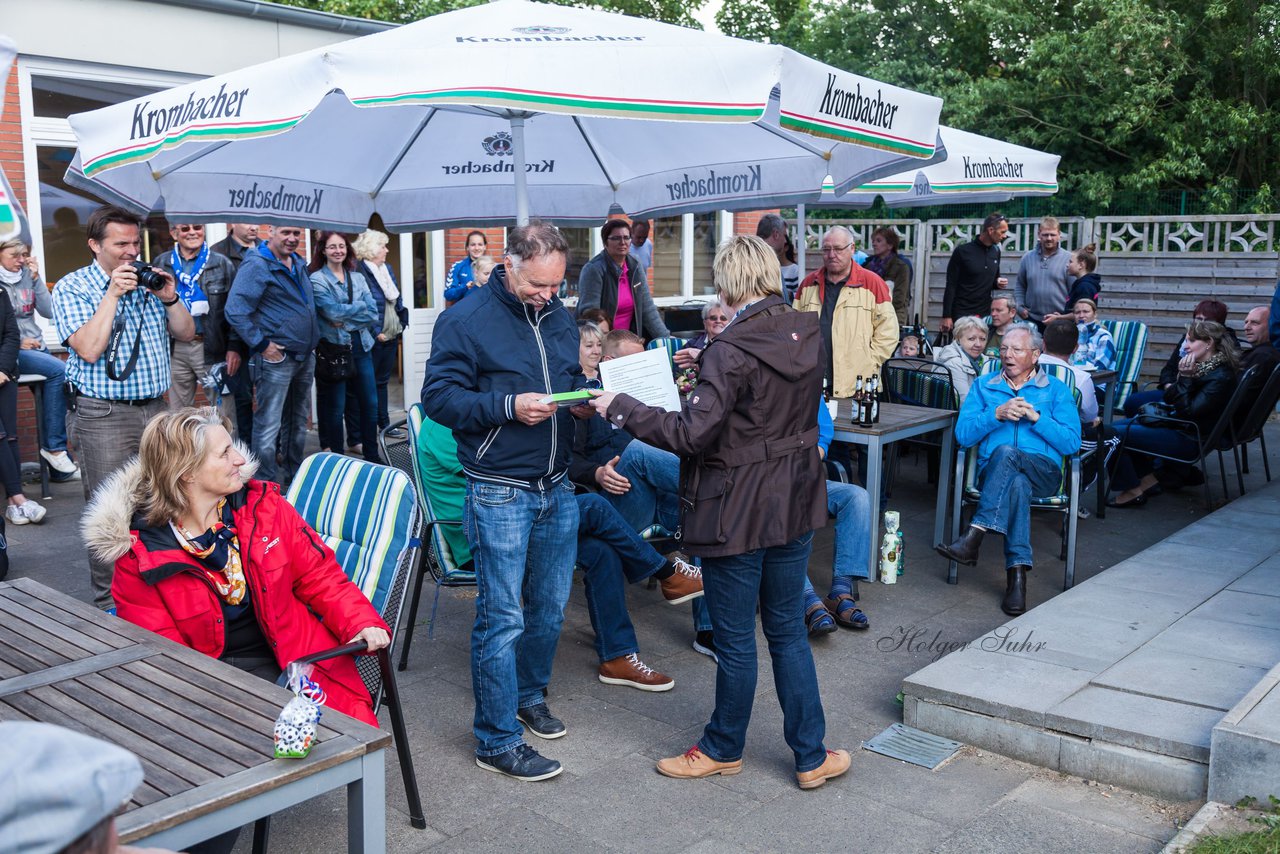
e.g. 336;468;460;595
227;225;320;484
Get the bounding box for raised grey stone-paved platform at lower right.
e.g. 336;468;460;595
904;481;1280;796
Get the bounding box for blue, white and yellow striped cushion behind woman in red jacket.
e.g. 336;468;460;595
288;452;419;613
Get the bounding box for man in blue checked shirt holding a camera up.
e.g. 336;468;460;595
54;206;196;611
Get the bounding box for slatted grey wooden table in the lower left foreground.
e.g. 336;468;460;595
0;579;390;851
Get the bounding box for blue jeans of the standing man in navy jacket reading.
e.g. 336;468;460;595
463;478;577;757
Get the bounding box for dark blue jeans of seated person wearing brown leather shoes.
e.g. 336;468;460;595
577;493;667;662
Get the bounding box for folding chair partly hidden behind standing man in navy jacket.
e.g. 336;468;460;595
378;403;476;670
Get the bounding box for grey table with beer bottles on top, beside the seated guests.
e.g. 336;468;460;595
836;399;956;580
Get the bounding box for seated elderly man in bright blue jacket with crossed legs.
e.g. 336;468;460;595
937;325;1080;616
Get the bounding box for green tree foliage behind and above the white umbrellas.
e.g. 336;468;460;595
284;0;1280;213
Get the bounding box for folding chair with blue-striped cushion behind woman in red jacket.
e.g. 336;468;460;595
253;452;426;853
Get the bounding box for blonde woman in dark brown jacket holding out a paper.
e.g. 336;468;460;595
591;236;850;789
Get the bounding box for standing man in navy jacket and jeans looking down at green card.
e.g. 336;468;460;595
422;222;585;780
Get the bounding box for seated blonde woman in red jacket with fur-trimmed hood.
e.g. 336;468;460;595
84;407;390;726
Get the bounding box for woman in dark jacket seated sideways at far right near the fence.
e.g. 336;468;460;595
1107;320;1240;507
